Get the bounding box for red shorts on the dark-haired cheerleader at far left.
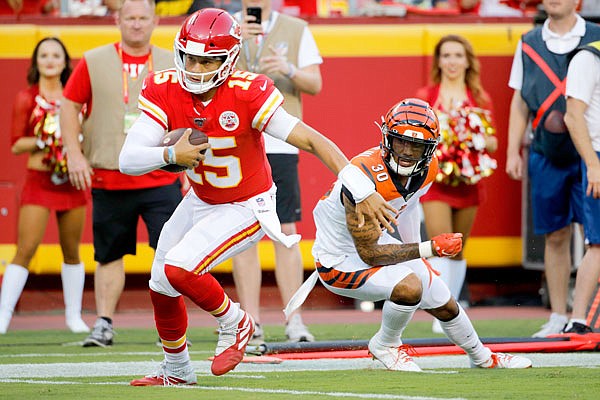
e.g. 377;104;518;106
21;169;90;211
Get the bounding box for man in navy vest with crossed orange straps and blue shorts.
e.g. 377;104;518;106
506;0;600;337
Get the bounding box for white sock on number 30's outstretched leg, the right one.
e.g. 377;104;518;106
440;304;492;365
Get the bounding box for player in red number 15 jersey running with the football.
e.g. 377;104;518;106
119;8;396;386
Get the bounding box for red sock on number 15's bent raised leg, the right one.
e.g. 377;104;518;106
165;264;243;325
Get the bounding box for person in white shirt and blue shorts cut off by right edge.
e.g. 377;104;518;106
564;41;600;333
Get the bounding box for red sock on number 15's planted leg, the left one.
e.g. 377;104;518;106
150;290;190;363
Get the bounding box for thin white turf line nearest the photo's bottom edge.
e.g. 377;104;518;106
0;379;467;400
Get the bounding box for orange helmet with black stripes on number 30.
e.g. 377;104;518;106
381;98;440;176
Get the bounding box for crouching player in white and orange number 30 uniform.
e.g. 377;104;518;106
285;99;531;372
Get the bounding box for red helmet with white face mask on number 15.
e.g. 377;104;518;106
174;8;242;94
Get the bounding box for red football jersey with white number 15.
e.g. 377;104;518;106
139;69;283;204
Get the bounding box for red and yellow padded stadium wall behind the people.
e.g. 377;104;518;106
0;23;532;274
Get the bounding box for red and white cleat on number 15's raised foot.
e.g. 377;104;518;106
210;311;254;376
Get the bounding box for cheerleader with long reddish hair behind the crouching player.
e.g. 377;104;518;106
417;35;498;333
